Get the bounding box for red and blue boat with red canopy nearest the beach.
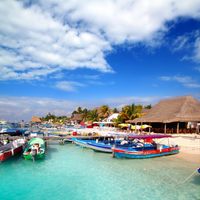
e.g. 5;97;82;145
112;135;179;158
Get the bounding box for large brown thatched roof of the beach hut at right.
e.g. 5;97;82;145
132;96;200;123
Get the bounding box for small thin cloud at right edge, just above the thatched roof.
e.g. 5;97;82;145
159;76;200;88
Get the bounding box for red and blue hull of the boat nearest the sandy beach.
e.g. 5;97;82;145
112;147;179;159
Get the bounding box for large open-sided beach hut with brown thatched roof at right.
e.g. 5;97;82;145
132;96;200;133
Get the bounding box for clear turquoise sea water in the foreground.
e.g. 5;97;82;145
0;143;200;200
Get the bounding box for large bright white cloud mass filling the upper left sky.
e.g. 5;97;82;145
0;0;111;80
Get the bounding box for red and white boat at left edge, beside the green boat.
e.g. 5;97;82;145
0;139;25;161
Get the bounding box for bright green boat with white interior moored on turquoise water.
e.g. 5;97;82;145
23;138;46;160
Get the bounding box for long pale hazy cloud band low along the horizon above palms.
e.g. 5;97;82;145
0;97;160;121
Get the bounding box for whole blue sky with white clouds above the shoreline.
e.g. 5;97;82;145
0;0;200;120
